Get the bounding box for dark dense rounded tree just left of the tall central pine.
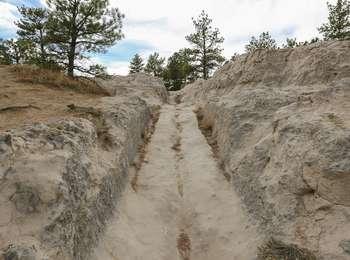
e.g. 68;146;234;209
163;49;198;91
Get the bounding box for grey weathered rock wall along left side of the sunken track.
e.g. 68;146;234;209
0;75;167;260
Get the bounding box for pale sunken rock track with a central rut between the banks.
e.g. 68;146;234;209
92;101;260;260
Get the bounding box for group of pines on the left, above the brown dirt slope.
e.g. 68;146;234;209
0;0;124;76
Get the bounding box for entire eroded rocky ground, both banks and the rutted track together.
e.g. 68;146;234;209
0;41;350;260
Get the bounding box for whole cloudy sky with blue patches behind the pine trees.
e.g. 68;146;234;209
0;0;336;75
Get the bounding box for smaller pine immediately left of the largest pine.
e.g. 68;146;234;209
16;6;49;65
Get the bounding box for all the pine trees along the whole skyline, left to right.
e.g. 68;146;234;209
0;0;350;87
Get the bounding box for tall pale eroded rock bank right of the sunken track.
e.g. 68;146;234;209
182;41;350;259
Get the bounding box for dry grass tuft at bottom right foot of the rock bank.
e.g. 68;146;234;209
258;238;316;260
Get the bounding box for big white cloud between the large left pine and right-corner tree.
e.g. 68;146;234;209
111;0;335;74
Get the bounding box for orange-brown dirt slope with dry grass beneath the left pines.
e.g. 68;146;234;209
0;66;101;132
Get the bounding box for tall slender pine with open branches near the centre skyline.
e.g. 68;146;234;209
186;11;225;79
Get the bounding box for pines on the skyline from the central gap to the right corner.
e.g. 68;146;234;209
130;0;350;91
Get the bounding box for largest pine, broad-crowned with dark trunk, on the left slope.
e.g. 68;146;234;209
47;0;124;76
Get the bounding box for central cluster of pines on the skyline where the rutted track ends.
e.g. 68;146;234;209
130;11;225;91
